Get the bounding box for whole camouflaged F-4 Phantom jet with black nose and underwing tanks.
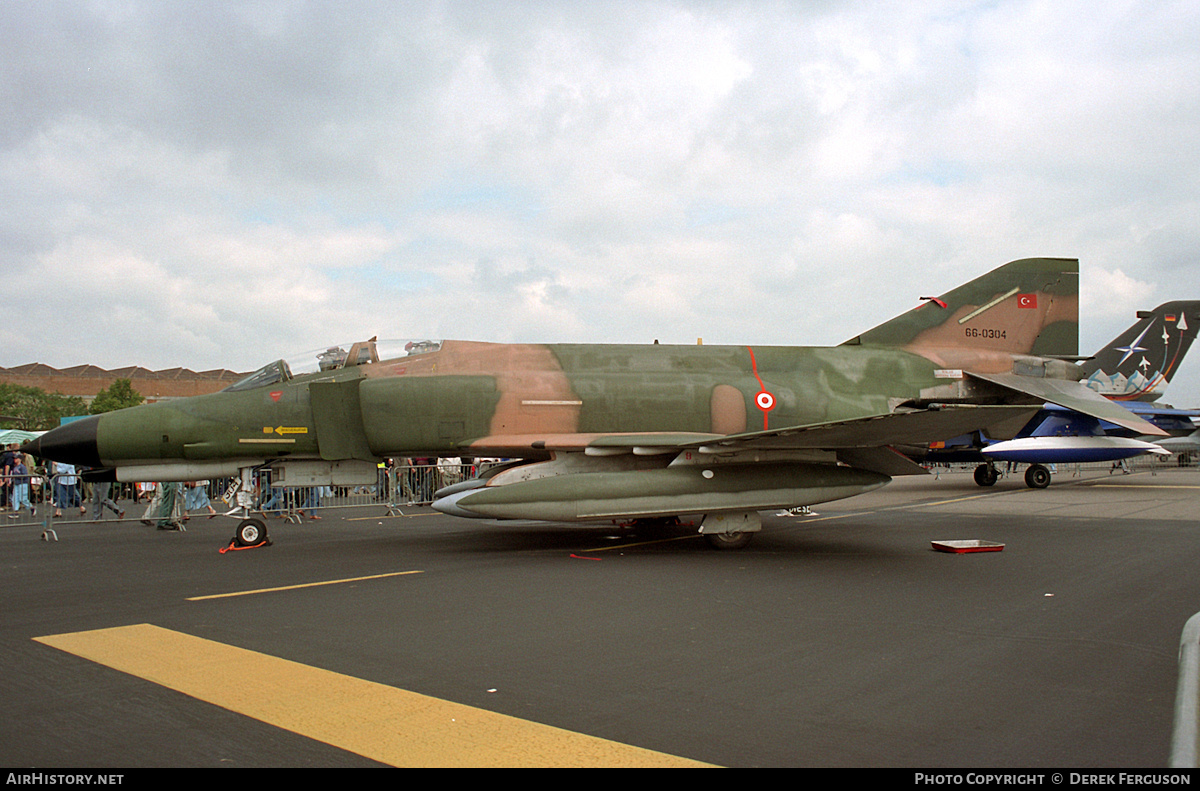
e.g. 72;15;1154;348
25;258;1163;547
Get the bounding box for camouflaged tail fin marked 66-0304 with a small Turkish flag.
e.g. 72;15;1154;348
846;258;1079;356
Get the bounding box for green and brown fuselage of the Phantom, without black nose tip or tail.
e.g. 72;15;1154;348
65;341;947;467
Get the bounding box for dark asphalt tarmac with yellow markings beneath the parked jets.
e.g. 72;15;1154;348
0;468;1200;768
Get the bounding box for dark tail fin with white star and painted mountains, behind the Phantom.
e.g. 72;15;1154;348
1082;301;1200;401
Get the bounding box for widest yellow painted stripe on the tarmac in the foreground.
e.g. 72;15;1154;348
35;623;706;767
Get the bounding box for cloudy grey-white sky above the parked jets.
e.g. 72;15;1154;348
0;0;1200;406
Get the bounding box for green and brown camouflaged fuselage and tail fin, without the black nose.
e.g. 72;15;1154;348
77;258;1079;466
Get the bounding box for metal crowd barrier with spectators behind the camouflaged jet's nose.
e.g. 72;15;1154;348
0;460;479;527
